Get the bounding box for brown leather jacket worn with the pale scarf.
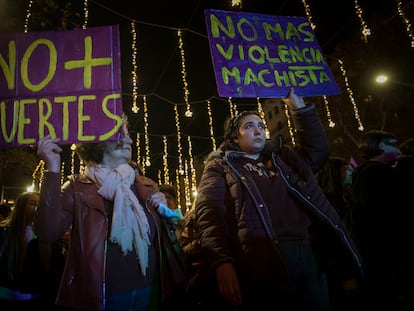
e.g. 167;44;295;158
35;172;161;310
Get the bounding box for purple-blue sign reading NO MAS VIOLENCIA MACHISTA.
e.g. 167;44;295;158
204;9;340;98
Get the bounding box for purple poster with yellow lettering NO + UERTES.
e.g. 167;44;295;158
0;25;122;147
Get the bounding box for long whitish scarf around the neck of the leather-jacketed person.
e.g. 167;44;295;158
85;164;150;276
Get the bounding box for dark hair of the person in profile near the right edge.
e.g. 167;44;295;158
358;130;397;160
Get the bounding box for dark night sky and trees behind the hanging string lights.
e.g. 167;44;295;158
0;0;414;197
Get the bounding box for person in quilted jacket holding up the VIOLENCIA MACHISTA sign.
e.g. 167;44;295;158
195;89;362;311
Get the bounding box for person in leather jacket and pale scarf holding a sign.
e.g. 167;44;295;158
35;117;185;311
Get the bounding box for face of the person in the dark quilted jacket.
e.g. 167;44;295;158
234;114;266;159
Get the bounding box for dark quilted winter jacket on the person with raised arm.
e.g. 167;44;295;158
195;106;362;286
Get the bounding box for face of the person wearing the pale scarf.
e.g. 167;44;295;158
102;126;132;168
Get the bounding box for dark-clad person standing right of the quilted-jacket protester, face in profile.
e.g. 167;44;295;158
352;130;401;310
